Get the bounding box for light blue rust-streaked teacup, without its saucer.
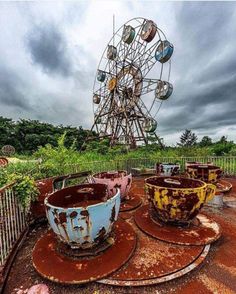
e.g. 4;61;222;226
44;184;120;249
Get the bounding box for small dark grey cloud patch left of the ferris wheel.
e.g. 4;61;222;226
27;24;72;76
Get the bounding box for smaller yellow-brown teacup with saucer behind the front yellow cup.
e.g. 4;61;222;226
186;163;232;196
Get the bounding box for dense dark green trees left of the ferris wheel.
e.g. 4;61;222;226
0;116;95;154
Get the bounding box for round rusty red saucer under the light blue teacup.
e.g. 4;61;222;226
32;220;136;284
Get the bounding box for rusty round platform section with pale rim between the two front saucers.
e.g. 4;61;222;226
99;219;210;287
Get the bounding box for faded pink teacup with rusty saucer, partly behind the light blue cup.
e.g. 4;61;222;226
91;170;142;212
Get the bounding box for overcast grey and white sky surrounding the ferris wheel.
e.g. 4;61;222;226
0;0;236;144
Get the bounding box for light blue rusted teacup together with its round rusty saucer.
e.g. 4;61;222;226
32;183;136;284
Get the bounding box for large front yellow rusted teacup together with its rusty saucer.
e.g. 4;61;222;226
135;176;221;245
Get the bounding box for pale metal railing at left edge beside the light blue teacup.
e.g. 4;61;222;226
0;184;28;267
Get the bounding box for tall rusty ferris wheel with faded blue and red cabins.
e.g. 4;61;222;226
92;18;174;146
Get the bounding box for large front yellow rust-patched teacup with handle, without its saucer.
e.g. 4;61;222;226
145;177;216;224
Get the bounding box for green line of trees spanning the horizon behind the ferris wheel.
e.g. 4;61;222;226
0;116;236;156
